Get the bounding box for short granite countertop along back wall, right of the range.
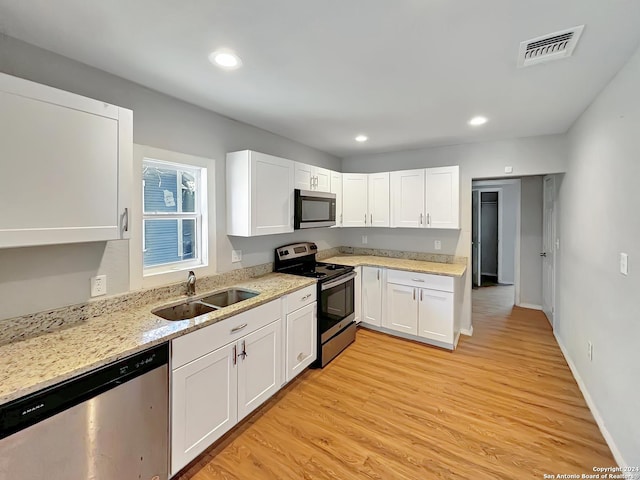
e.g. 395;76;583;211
323;255;467;277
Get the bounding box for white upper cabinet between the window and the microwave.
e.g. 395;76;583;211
227;150;294;237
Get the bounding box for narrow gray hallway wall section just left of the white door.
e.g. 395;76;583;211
518;176;543;307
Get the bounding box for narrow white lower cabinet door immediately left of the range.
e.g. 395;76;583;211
286;302;318;382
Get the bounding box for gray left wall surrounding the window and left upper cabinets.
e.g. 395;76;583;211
0;36;340;319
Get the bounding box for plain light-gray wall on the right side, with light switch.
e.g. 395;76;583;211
556;44;640;466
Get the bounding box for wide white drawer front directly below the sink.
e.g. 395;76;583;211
171;299;281;370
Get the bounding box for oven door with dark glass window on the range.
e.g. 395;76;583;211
318;272;356;343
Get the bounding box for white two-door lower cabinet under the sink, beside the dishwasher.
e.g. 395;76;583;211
171;300;283;475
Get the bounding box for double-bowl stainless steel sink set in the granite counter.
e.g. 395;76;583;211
151;288;258;321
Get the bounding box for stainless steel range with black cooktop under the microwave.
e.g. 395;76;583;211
274;242;356;367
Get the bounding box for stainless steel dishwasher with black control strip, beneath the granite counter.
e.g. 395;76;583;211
0;344;169;480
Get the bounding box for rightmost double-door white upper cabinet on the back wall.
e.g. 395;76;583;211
391;166;460;229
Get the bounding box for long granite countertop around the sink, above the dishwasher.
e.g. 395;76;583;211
0;273;316;405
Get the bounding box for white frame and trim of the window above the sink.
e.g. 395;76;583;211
130;144;216;290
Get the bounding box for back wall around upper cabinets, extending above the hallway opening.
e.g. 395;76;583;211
342;135;567;329
